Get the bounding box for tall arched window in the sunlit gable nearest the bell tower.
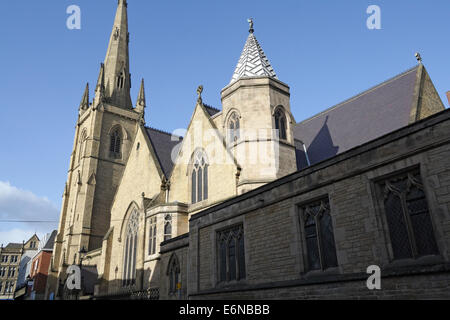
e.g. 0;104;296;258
123;209;139;286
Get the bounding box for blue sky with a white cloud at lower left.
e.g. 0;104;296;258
0;0;450;245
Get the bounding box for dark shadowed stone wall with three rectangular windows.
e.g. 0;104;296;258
188;111;450;299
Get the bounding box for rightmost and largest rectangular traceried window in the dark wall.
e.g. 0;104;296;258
381;170;439;259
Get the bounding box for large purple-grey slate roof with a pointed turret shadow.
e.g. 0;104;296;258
294;66;419;169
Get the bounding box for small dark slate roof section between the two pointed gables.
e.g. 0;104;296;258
145;127;183;177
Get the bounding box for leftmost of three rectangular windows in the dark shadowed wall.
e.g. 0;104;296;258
217;225;246;282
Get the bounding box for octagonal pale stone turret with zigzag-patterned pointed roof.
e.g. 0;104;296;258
221;19;297;194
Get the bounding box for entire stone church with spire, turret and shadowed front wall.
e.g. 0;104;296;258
46;0;450;299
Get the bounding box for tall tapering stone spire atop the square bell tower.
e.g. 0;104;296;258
104;0;132;109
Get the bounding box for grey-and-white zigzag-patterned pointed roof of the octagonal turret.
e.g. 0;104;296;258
230;19;278;84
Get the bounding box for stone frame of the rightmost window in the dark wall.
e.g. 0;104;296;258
370;162;444;268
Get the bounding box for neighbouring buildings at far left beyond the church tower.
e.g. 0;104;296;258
0;235;39;300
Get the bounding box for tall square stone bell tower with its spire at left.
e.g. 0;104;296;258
51;0;145;292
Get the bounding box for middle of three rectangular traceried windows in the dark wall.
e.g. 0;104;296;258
302;199;338;271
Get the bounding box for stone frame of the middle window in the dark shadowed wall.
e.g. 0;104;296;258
297;194;341;276
